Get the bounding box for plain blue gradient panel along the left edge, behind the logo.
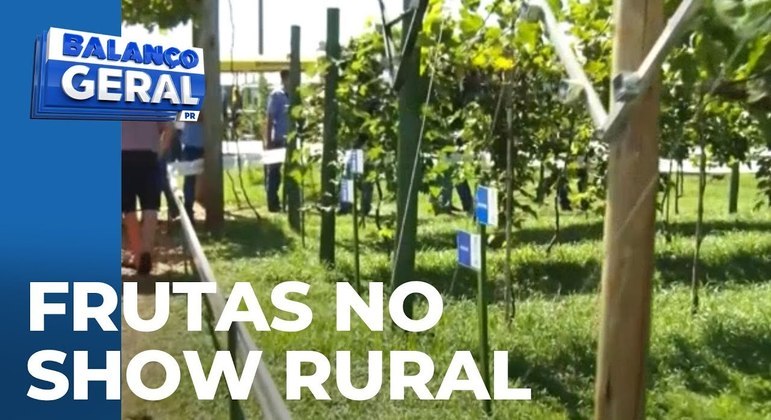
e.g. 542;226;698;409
0;0;121;420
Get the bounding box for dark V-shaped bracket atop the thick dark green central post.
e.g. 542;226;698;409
379;0;428;91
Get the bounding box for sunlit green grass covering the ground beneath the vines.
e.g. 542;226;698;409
123;171;771;419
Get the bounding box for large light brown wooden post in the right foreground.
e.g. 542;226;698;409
595;0;663;420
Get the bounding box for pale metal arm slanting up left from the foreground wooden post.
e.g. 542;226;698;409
519;0;608;128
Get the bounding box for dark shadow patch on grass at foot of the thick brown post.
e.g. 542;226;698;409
197;215;292;259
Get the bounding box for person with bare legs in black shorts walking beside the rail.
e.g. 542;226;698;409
121;121;173;275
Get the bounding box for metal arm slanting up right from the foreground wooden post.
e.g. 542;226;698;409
597;0;704;142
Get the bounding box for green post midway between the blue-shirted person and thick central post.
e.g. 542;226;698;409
319;9;340;265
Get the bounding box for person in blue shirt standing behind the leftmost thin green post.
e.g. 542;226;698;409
264;70;289;213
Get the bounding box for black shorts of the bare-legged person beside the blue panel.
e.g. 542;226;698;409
121;150;161;213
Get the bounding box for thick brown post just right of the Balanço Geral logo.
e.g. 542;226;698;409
198;0;225;230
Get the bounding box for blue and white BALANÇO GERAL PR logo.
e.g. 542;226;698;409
30;28;206;121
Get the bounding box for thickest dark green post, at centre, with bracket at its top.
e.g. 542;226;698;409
391;0;425;317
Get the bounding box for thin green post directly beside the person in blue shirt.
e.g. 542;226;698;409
284;25;302;232
